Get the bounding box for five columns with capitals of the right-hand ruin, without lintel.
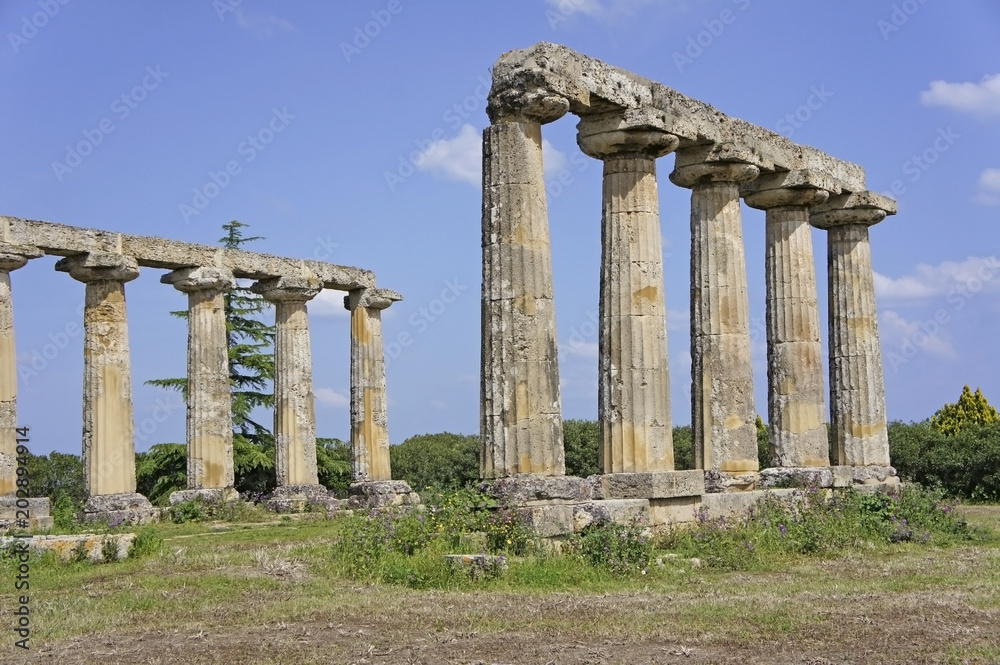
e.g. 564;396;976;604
481;96;895;477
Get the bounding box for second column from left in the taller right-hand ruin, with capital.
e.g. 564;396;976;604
577;112;678;473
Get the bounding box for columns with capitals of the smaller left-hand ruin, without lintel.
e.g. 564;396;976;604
0;244;400;503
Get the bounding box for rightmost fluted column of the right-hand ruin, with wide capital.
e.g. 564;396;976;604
809;192;896;467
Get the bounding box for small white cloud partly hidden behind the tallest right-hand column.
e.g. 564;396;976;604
415;123;568;186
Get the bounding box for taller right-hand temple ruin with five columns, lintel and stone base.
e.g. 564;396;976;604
481;43;896;535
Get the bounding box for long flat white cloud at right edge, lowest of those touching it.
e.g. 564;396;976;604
875;256;1000;301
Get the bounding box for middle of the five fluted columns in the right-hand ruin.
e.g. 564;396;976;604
670;148;758;485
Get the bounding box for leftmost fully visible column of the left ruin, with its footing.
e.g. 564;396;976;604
56;252;153;521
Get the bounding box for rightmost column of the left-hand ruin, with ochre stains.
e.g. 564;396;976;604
344;289;402;483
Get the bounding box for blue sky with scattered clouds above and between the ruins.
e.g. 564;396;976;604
0;0;1000;453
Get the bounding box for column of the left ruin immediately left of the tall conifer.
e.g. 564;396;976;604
160;267;236;503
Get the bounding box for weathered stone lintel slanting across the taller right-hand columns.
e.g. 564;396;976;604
490;42;865;191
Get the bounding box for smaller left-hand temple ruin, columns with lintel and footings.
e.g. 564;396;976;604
0;217;410;521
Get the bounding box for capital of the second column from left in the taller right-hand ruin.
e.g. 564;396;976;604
576;108;680;160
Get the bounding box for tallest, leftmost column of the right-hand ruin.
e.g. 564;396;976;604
480;89;569;478
